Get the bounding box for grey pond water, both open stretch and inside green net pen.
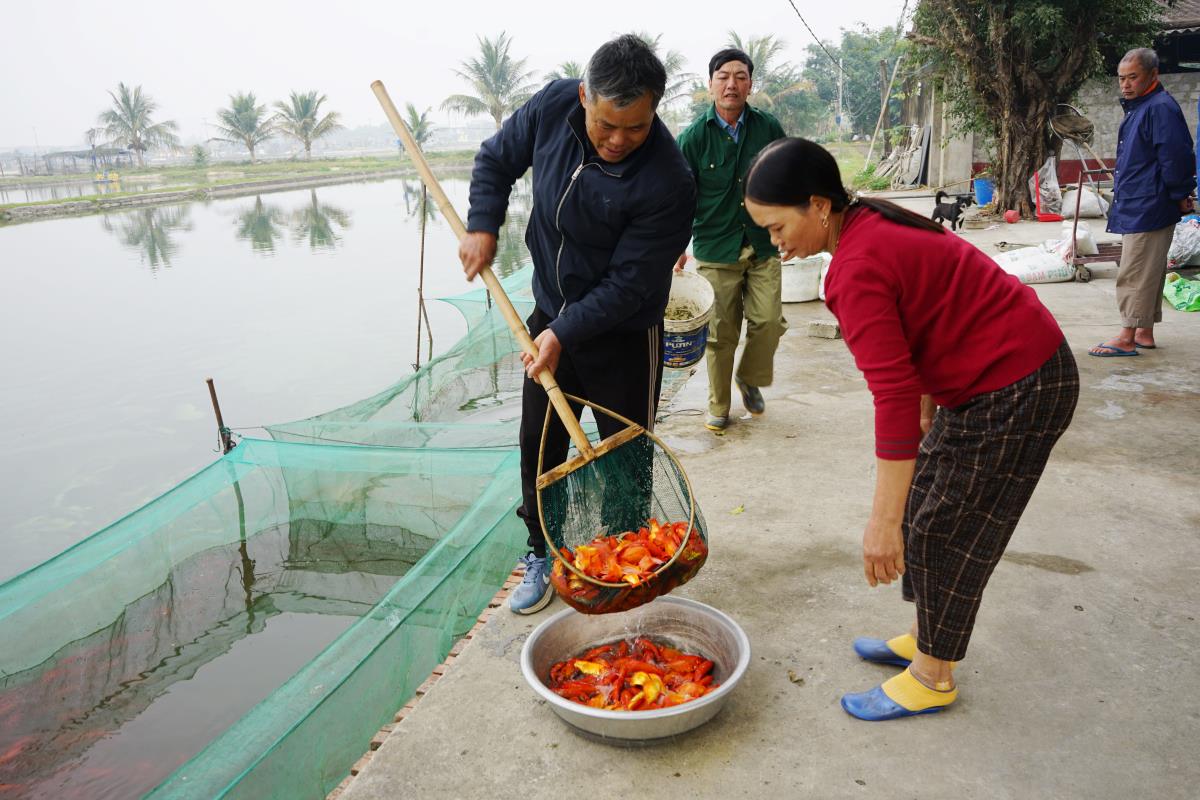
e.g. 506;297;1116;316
0;179;528;800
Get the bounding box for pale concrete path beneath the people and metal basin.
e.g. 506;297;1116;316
342;205;1200;800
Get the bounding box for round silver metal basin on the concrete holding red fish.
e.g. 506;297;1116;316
521;596;750;746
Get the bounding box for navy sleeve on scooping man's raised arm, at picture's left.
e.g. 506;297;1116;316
467;89;546;234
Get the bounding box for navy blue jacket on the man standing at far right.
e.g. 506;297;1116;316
1109;84;1196;234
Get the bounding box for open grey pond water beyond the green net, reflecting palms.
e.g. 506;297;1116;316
0;179;529;581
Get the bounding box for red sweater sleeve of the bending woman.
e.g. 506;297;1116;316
835;253;922;461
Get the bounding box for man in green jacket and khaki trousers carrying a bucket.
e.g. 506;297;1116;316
676;48;787;431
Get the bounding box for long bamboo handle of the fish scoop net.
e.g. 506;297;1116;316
371;80;595;461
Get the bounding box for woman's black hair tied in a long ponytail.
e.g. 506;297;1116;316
746;138;946;234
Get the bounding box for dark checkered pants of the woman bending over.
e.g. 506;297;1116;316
902;342;1079;661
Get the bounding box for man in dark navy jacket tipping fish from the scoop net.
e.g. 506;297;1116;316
458;35;696;614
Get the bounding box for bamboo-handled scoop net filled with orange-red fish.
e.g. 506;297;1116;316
371;80;708;614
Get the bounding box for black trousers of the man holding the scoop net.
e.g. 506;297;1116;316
517;308;662;557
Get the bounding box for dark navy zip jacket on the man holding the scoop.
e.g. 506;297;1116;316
467;79;696;348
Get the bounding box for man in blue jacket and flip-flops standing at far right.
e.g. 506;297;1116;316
1088;48;1195;357
